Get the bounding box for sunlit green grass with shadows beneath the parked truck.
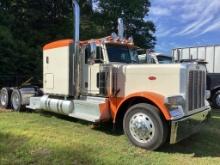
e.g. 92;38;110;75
0;111;220;165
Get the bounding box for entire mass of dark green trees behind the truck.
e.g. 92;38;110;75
0;0;155;79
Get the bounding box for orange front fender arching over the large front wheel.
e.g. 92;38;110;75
110;92;171;122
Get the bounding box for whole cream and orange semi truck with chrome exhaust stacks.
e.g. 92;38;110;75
1;0;211;150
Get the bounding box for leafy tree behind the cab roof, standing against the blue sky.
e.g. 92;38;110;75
96;0;156;49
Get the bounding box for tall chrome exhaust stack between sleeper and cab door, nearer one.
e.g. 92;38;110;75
72;0;80;98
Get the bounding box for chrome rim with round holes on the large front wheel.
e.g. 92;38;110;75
129;113;155;143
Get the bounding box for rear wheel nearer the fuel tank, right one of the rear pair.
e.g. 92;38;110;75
11;89;23;111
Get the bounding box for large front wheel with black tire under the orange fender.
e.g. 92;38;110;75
123;103;168;150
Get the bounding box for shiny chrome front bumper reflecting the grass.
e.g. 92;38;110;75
170;107;211;144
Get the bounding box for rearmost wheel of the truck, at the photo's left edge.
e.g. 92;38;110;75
0;88;12;109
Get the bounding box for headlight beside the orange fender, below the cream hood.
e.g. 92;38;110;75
165;96;185;120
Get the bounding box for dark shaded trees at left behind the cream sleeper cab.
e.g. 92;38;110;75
0;0;92;85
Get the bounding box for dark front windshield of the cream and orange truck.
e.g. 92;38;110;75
106;44;138;63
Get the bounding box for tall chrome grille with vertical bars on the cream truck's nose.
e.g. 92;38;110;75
188;70;206;111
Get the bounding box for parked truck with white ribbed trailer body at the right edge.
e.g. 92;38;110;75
172;45;220;109
